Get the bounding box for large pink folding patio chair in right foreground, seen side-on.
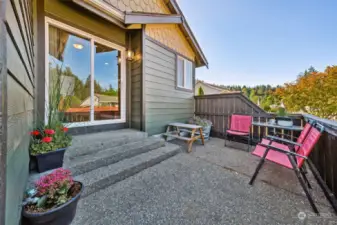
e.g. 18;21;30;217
249;124;336;214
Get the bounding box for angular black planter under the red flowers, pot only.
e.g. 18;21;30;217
32;148;67;173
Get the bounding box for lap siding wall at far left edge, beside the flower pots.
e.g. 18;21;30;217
5;0;35;224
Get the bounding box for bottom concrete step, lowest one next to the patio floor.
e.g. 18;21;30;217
74;143;181;197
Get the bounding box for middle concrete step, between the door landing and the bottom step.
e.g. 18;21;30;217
63;137;165;176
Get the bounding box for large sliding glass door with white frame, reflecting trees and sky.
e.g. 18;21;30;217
46;18;125;126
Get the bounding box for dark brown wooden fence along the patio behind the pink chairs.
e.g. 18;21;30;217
195;93;337;196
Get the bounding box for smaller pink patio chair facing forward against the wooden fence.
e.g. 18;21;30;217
225;114;253;150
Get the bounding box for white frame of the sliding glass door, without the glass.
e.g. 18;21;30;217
44;17;126;127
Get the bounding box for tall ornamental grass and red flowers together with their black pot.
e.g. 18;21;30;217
30;62;75;173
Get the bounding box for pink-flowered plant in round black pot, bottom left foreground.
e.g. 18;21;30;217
22;168;83;225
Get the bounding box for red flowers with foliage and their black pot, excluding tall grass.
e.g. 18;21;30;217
30;123;72;173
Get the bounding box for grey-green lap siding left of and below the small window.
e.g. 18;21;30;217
144;39;194;135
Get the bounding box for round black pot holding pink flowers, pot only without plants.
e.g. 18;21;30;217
22;181;84;225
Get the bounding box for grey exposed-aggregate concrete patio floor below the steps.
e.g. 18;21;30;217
72;138;337;225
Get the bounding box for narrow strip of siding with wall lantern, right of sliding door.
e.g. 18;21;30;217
131;32;142;130
